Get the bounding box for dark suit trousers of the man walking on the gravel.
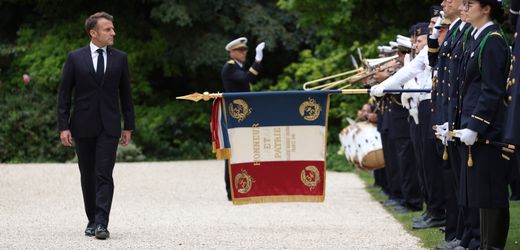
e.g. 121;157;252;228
74;130;119;226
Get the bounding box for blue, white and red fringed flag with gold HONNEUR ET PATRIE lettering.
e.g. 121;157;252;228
211;91;330;204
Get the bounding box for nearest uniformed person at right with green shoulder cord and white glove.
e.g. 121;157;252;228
455;0;510;249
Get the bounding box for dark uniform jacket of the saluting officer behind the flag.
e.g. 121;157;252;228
221;60;260;92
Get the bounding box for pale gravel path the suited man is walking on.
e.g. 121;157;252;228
0;161;421;249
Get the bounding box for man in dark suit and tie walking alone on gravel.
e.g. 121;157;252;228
58;12;135;239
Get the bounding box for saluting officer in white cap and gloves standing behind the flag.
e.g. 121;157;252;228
221;37;265;200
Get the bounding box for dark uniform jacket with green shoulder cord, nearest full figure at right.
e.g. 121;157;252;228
459;24;509;139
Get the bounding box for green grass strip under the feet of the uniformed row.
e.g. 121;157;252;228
358;171;520;249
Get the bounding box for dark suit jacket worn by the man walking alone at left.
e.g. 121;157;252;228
58;46;135;138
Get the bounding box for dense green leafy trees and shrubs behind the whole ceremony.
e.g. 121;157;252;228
0;0;492;170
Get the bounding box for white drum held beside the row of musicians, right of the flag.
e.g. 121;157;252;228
339;122;385;170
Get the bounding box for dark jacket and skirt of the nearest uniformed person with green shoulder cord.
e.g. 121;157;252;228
458;24;510;208
